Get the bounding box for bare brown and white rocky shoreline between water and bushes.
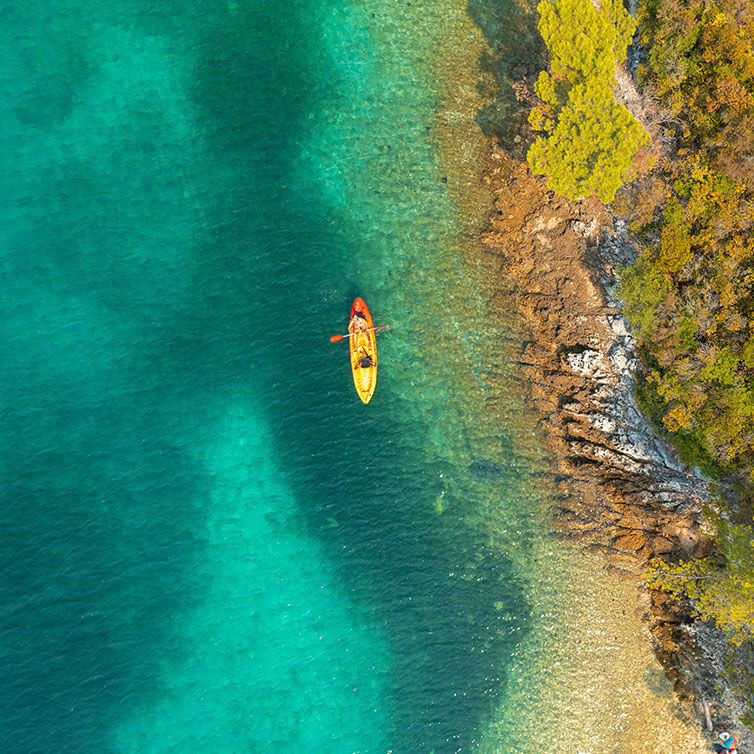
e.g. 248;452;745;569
476;145;739;744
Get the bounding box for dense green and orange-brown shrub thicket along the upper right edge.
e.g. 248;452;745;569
621;0;754;464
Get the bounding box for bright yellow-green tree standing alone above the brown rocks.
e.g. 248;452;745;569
527;0;649;202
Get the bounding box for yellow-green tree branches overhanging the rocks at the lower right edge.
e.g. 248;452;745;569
647;519;754;645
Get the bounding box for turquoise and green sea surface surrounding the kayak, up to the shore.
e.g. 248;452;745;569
0;0;708;754
